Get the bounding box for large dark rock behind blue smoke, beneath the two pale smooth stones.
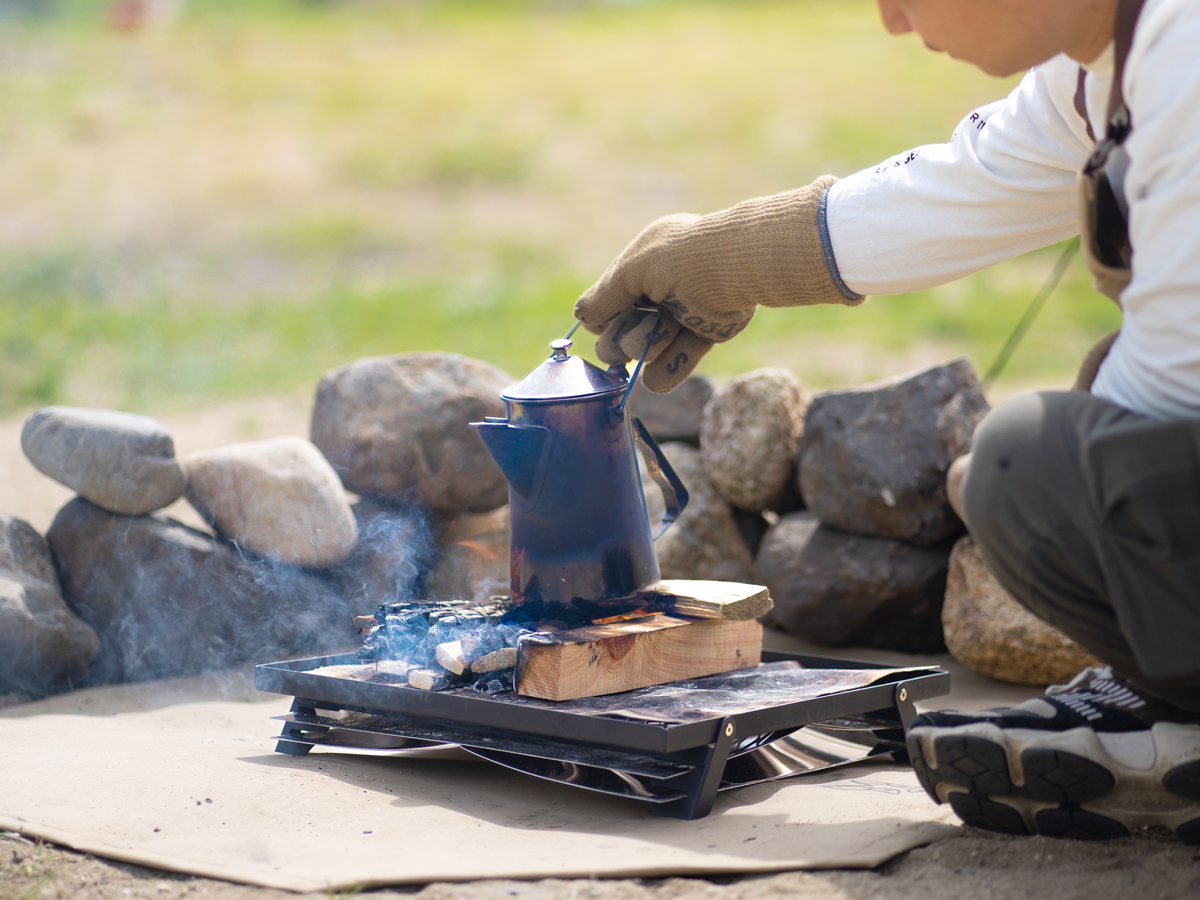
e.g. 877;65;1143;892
46;498;358;682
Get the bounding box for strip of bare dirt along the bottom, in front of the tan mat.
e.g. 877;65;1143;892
7;829;1200;900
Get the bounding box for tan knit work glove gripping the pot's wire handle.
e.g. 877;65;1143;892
575;175;864;394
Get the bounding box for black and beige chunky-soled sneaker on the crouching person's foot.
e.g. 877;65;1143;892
908;668;1200;844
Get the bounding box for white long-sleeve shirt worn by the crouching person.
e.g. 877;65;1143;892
826;0;1200;419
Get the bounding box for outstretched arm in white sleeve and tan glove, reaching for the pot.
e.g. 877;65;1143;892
575;54;1090;391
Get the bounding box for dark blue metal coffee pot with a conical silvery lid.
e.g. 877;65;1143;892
470;329;688;619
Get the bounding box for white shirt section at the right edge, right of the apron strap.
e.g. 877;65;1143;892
1092;0;1200;419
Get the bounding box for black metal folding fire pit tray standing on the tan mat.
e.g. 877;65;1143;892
254;650;950;818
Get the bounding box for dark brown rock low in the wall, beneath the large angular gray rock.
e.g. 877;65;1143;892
755;512;950;653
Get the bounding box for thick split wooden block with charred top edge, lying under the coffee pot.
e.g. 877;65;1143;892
516;614;762;700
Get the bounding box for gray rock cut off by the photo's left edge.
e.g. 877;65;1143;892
0;516;100;694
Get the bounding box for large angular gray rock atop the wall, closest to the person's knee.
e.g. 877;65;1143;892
799;359;988;546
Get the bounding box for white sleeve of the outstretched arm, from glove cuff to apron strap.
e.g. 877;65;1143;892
826;56;1106;294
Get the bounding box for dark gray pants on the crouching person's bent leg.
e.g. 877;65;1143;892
962;391;1200;712
